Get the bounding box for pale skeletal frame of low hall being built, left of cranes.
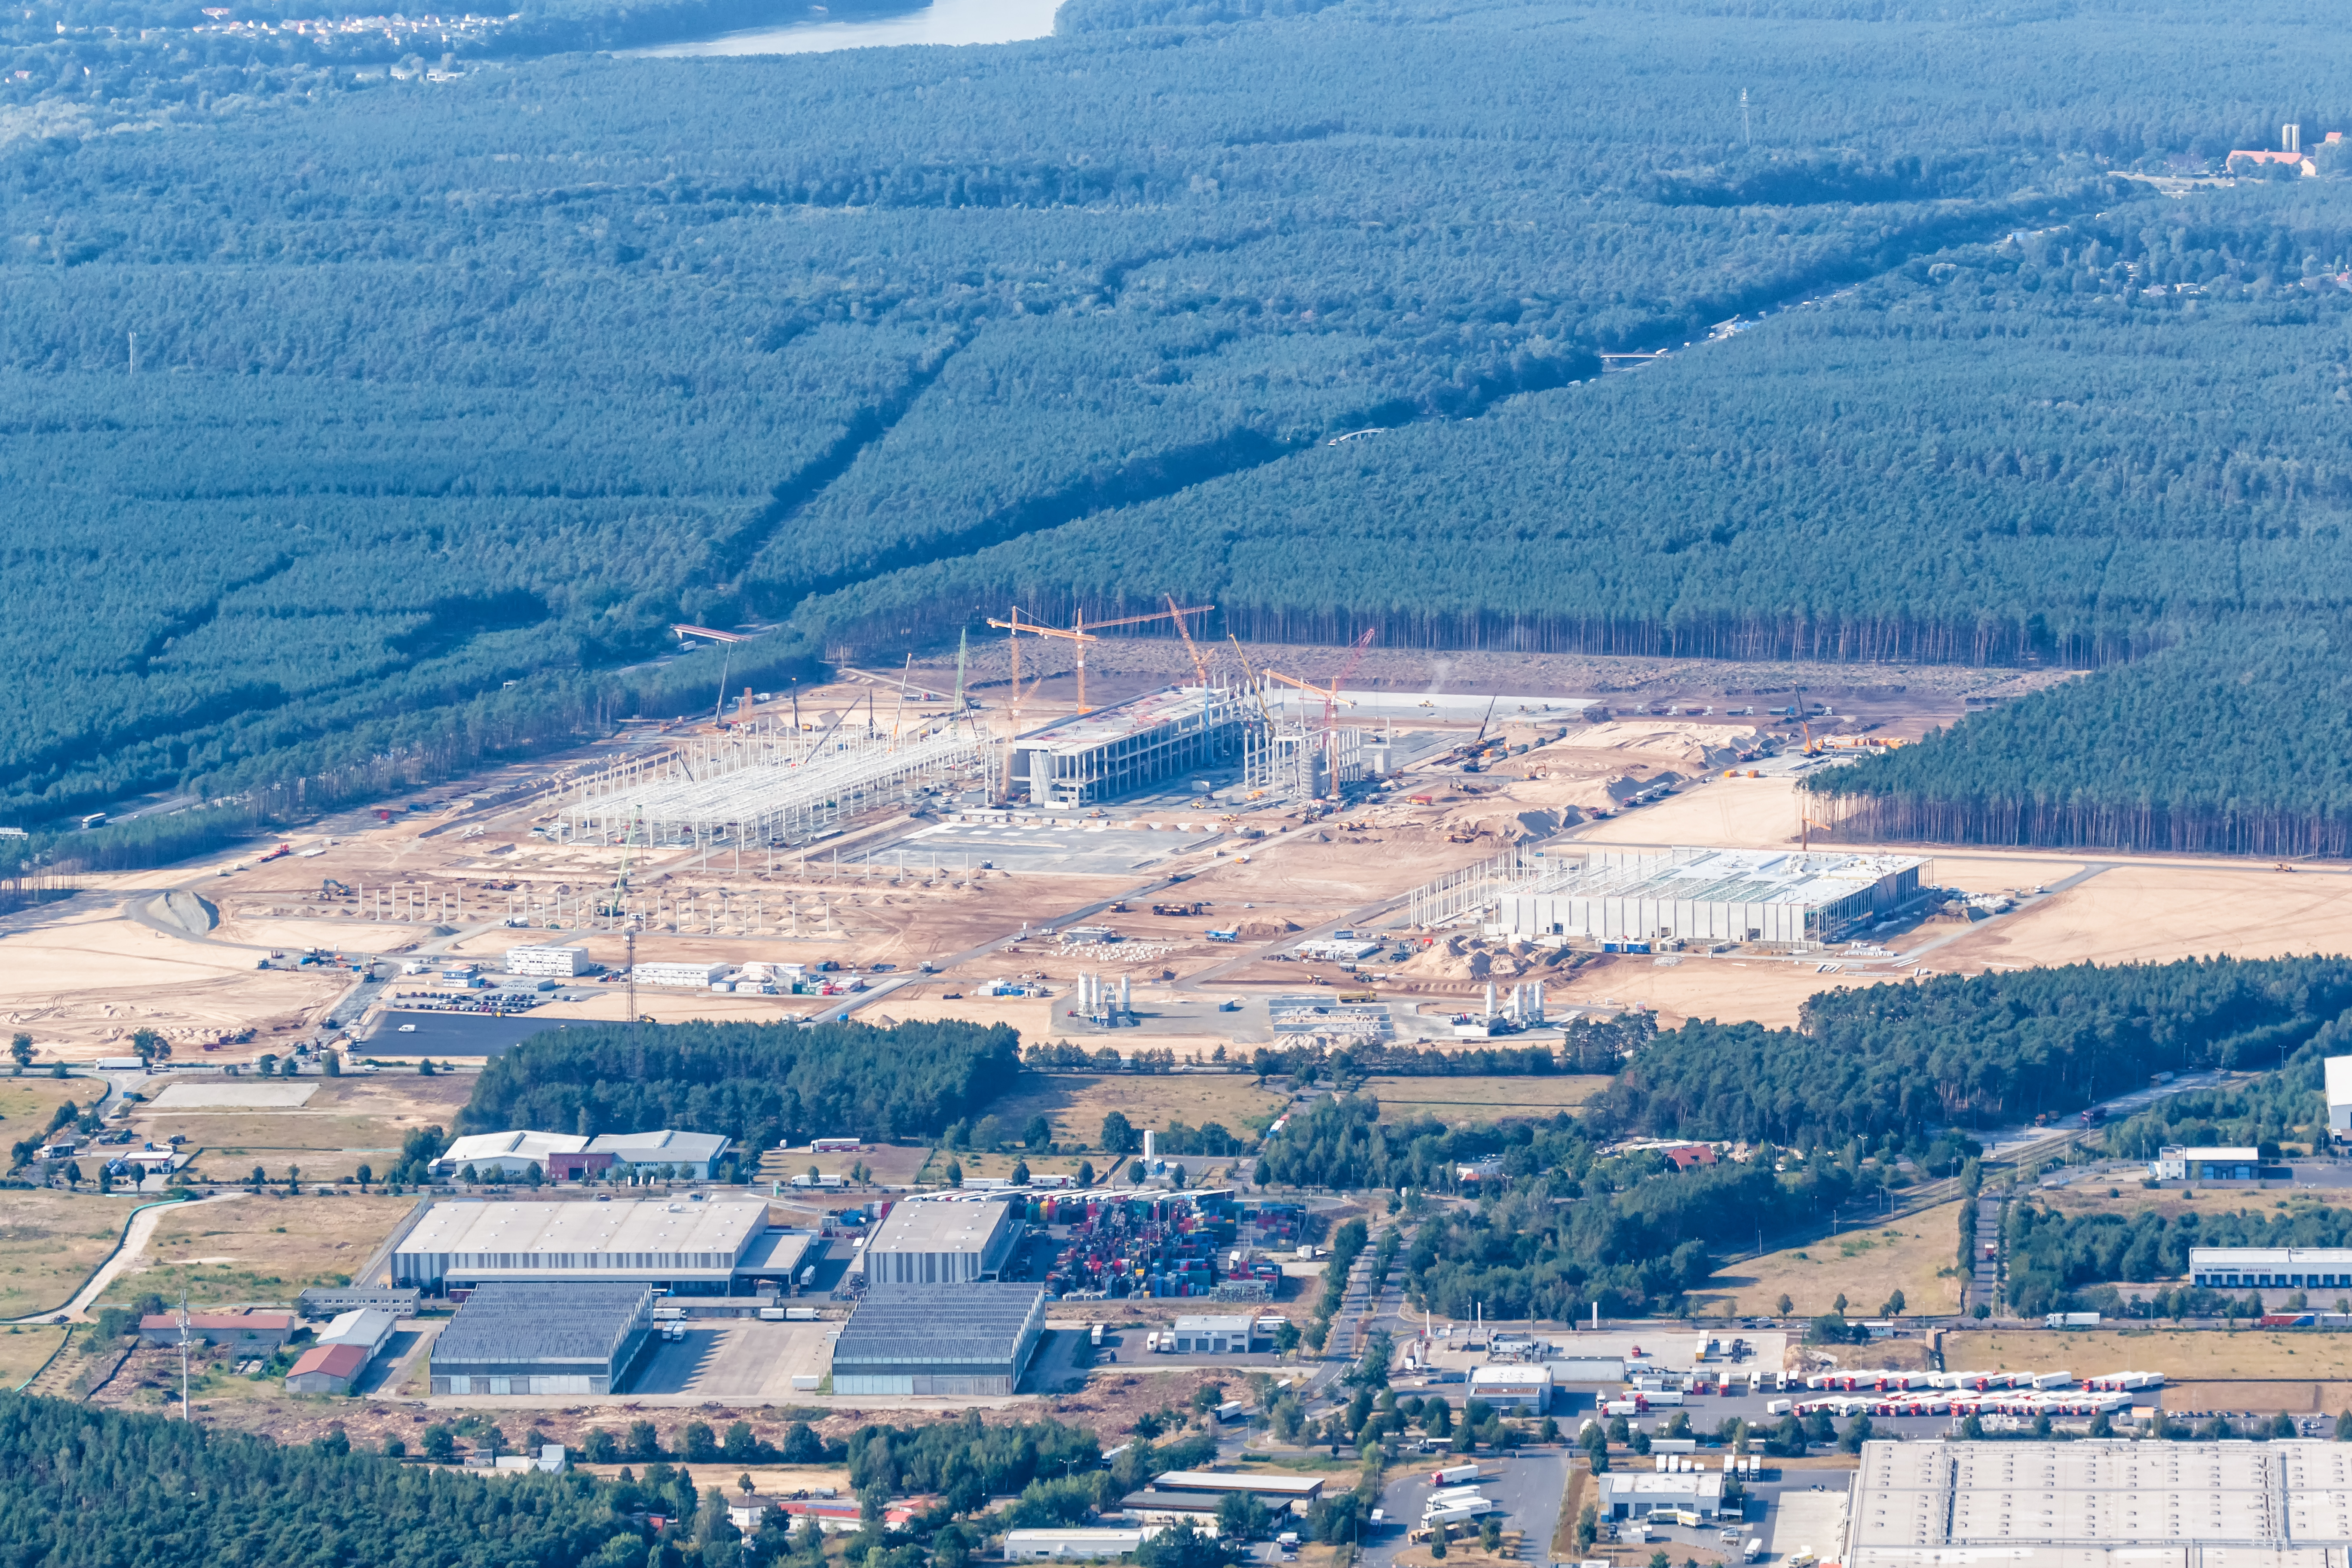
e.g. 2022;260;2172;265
564;724;986;848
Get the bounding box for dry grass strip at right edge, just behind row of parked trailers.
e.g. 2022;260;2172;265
1943;1328;2352;1403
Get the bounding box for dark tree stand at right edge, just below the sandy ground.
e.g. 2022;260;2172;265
1585;957;2352;1145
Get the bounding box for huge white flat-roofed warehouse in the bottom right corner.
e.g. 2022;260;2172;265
1820;1441;2352;1568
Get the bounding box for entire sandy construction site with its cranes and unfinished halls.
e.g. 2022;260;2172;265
14;625;2352;1065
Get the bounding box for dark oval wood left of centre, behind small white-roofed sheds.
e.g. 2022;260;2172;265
459;1020;1021;1149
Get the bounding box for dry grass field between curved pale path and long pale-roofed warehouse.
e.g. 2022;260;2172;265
101;1192;416;1305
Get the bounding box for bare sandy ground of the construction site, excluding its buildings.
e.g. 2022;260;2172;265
0;642;2352;1081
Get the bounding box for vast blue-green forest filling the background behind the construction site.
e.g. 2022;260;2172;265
14;0;2352;827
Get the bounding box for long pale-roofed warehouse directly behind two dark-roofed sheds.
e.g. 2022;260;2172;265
390;1199;816;1295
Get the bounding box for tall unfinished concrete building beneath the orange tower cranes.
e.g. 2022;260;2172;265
1004;686;1254;806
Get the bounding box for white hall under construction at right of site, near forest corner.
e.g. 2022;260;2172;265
1489;848;1931;947
